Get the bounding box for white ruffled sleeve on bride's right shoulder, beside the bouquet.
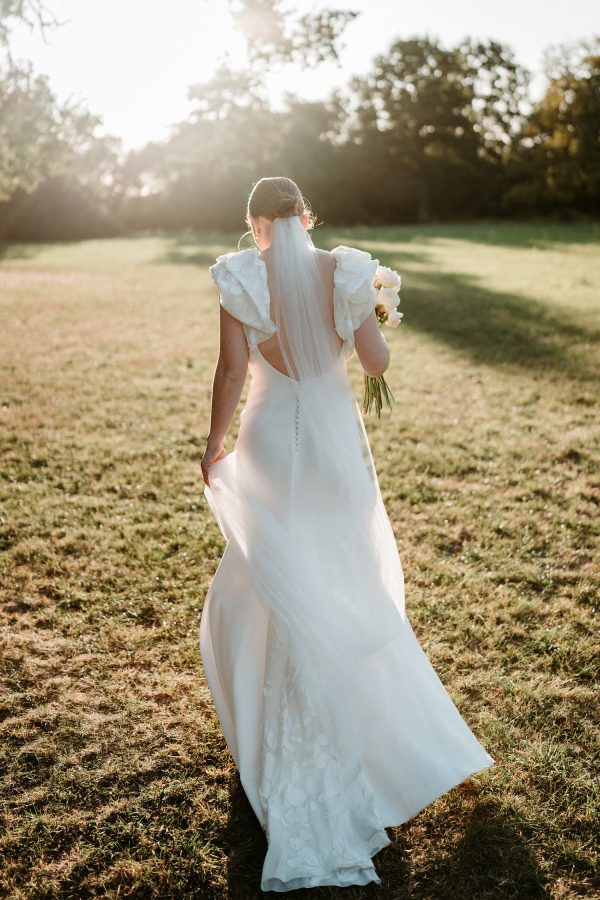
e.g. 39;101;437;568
331;245;379;353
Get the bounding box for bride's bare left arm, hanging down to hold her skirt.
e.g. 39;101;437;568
200;306;248;484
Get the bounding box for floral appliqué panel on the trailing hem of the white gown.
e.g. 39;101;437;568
259;626;389;890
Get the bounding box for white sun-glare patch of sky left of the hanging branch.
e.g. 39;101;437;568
7;0;244;149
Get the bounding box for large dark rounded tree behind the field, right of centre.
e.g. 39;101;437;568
338;38;526;221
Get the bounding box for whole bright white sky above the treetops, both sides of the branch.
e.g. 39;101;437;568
13;0;600;149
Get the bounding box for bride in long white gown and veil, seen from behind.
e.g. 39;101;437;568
199;177;493;891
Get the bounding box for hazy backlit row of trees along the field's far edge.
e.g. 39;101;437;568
0;0;600;240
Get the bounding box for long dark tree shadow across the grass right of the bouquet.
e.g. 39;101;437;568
323;232;600;381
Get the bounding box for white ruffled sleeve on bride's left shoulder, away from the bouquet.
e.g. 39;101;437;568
209;248;276;346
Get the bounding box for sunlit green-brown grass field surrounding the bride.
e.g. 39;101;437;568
0;224;600;900
